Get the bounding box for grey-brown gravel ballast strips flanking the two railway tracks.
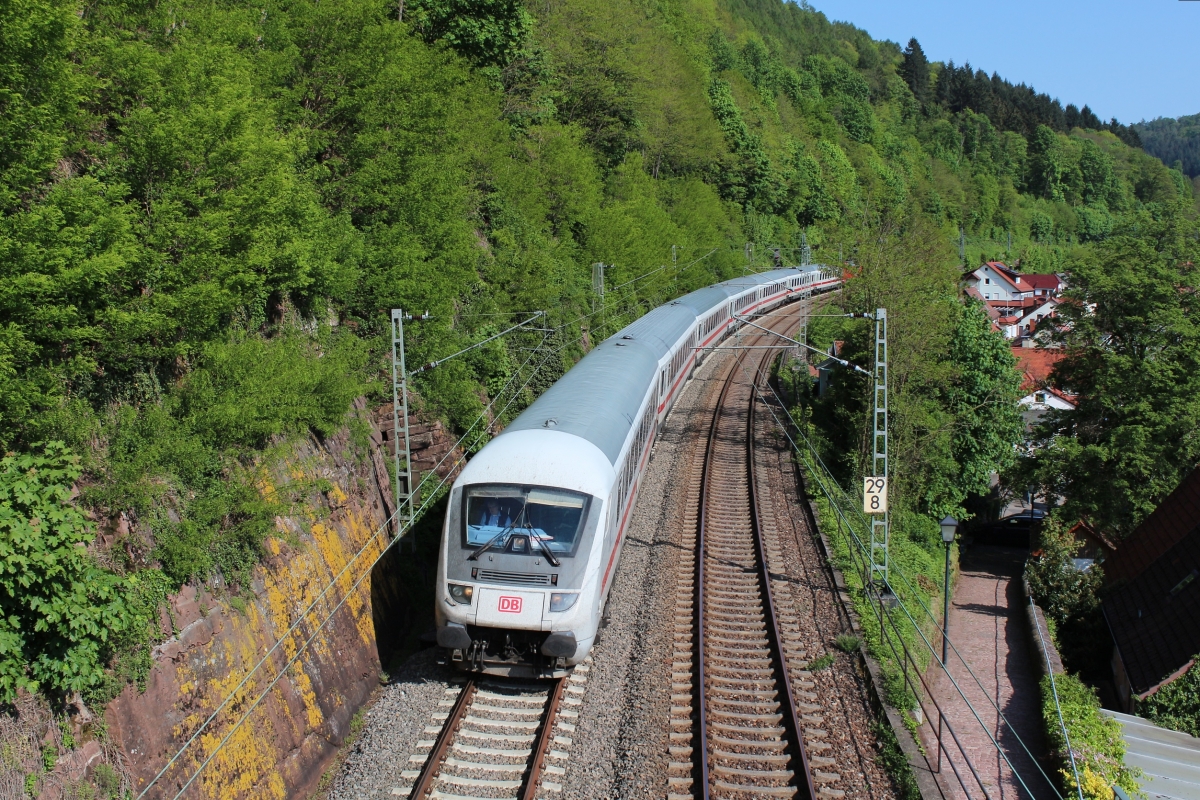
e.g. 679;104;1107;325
328;299;893;800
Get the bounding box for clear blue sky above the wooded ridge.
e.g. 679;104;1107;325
810;0;1200;122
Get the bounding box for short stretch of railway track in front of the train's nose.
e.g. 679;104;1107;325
391;664;588;800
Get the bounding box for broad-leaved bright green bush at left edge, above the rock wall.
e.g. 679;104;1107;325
0;443;137;702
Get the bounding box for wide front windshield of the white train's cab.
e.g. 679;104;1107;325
463;483;588;563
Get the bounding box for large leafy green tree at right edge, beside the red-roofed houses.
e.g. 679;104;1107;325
1022;206;1200;536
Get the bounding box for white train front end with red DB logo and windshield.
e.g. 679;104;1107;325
436;429;613;678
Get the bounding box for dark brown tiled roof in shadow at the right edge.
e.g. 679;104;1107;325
1104;469;1200;694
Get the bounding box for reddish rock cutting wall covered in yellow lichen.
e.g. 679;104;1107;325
106;405;412;799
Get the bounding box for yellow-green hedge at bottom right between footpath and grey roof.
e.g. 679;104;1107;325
1042;673;1144;800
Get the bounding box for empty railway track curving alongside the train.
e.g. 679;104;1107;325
668;307;845;800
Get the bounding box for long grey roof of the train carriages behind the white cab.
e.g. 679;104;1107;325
496;265;820;465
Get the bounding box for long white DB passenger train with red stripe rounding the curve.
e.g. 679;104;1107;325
436;266;841;678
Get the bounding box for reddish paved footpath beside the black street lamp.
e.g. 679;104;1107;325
920;546;1057;800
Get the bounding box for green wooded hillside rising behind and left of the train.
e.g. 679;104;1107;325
0;0;1195;703
